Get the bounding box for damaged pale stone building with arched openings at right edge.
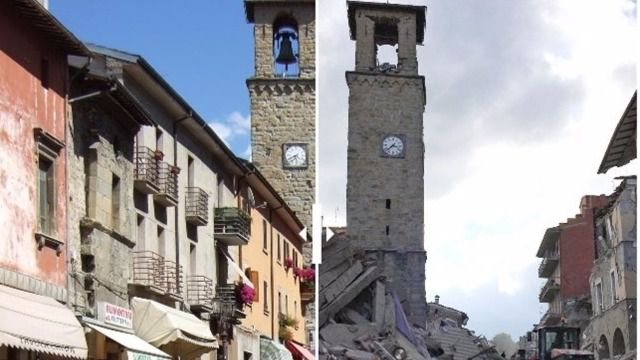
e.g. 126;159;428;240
586;176;637;359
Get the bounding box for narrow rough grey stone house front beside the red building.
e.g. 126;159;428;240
68;98;135;316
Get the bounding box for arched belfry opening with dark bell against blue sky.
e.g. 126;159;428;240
273;16;300;77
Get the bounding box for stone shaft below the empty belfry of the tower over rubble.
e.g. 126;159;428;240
347;72;427;326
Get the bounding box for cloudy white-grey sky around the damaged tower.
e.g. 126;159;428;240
317;0;637;338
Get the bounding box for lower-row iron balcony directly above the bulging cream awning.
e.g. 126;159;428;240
131;251;182;299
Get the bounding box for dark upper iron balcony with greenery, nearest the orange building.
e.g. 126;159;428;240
218;207;251;245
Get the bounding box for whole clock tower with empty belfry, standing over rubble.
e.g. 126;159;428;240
346;1;427;327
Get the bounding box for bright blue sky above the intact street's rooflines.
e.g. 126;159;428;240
49;0;253;157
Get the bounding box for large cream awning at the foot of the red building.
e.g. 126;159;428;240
0;285;87;359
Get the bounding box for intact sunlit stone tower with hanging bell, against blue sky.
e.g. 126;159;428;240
244;0;316;249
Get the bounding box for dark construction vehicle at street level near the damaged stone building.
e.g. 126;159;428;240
537;326;594;360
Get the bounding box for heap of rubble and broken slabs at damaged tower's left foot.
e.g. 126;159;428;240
318;233;431;360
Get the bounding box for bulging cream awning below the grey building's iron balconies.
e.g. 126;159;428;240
131;297;218;358
